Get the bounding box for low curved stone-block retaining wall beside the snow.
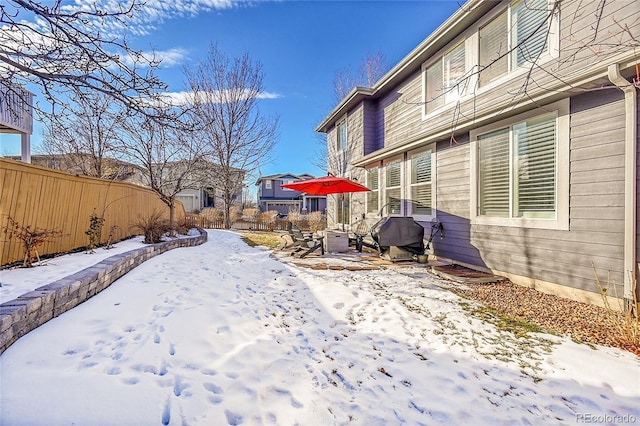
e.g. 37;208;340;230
0;229;207;354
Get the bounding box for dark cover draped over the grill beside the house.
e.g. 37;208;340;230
371;216;424;254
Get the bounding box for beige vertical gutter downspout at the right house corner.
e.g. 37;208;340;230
608;64;638;311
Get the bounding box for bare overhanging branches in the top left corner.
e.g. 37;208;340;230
0;0;165;114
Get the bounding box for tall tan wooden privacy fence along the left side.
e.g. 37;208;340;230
0;159;185;266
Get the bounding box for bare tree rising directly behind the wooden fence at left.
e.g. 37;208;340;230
43;93;123;179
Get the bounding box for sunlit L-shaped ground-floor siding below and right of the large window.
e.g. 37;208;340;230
464;90;624;294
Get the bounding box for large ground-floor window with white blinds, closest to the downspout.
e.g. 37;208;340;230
477;114;557;219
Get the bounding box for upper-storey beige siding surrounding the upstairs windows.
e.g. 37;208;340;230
360;1;640;153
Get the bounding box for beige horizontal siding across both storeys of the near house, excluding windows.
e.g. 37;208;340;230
321;0;640;306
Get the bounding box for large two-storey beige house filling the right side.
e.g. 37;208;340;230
316;0;640;304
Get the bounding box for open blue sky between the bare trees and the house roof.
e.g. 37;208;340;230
0;0;461;176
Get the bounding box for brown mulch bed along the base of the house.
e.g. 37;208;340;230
455;280;640;356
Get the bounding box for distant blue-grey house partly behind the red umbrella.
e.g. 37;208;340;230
256;173;327;214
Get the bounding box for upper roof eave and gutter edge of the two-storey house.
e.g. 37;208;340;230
315;0;490;133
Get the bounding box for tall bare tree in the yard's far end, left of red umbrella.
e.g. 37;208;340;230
185;44;278;229
